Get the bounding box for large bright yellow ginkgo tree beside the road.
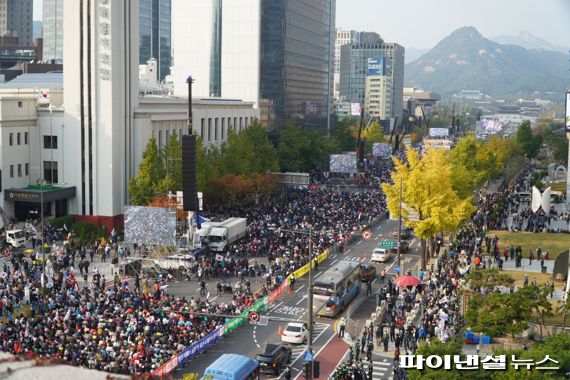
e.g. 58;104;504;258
382;149;475;269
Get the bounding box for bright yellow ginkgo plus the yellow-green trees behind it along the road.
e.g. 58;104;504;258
382;135;521;269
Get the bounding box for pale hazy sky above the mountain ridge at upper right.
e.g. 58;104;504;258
336;0;570;48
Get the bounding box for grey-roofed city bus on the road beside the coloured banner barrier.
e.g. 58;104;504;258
313;261;360;317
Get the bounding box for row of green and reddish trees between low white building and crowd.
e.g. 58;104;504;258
129;119;385;207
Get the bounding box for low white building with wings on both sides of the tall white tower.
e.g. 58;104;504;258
0;73;258;220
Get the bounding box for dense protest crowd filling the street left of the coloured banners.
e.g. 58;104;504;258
0;186;385;374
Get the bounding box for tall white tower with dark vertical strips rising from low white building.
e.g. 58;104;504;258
62;0;139;221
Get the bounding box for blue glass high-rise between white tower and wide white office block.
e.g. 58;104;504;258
139;0;172;80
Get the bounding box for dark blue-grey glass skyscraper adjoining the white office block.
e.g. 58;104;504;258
260;0;336;126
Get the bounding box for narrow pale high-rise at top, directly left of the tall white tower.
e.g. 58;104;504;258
43;0;63;62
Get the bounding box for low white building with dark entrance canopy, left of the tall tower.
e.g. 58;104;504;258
0;74;76;219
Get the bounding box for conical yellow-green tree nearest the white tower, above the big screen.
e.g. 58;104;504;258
129;137;165;205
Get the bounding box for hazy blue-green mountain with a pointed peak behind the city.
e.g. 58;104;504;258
405;27;569;96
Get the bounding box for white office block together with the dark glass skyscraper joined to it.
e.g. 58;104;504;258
172;0;336;127
